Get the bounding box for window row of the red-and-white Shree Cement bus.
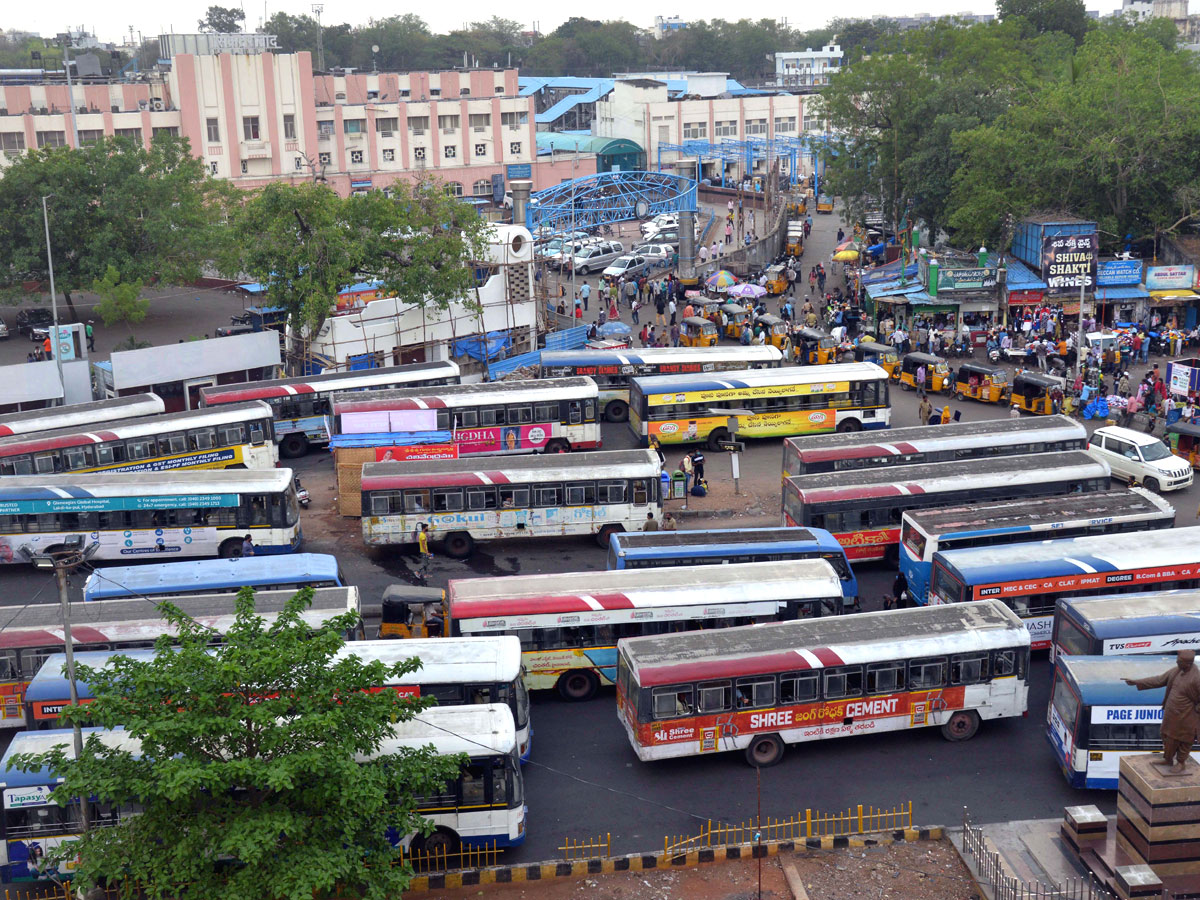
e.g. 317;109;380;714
650;650;1027;719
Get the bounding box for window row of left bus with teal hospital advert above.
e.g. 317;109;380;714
0;493;300;534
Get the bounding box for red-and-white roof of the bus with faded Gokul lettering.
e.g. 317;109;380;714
362;449;659;491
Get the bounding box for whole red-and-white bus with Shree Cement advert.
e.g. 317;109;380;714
617;601;1030;767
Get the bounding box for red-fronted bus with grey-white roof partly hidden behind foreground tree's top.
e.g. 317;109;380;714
0;587;366;728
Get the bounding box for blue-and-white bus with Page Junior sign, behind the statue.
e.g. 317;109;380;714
1046;655;1175;791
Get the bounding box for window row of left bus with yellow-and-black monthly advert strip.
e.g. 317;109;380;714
0;419;271;475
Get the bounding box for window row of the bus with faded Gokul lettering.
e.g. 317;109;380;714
370;478;659;516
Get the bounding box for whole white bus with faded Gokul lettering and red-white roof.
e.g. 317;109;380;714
362;450;662;558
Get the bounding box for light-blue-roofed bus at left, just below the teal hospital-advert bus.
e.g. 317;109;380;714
83;553;347;600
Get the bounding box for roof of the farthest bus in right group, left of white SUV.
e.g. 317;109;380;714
785;415;1087;462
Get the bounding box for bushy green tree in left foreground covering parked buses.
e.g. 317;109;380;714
19;588;461;900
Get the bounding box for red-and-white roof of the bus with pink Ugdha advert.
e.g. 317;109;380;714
331;376;596;415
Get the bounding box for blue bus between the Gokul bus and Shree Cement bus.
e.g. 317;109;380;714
608;528;858;605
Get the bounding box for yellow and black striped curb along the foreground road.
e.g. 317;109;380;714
408;826;944;894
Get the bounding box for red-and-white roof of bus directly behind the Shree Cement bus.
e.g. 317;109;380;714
446;559;841;631
